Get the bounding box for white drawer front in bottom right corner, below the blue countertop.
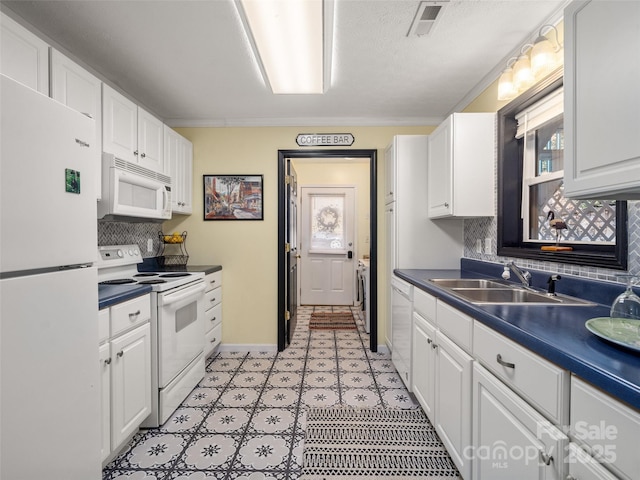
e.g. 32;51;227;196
570;376;640;480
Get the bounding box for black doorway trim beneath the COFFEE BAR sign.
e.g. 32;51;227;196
277;150;378;352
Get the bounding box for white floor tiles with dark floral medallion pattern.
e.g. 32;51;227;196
102;307;418;480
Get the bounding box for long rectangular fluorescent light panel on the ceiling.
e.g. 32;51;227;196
235;0;333;94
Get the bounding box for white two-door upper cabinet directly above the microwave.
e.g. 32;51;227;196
102;85;168;174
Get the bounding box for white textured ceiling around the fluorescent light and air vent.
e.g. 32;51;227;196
2;0;567;126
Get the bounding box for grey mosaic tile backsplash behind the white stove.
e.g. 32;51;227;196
98;220;162;258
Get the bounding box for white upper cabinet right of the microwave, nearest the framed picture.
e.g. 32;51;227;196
164;125;193;215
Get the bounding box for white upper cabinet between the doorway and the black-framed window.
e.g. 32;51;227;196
427;113;495;218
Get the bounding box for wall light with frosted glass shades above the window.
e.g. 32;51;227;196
498;25;562;101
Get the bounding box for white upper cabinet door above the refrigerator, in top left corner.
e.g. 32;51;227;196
0;12;49;95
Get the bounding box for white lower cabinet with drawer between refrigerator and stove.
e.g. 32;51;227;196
98;295;151;464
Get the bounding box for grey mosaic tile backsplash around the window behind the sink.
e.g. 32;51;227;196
464;201;640;281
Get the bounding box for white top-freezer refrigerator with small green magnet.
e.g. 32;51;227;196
0;75;101;480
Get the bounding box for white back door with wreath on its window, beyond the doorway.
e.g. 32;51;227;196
299;187;357;305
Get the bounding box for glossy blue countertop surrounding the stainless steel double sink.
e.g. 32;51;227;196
394;260;640;409
